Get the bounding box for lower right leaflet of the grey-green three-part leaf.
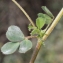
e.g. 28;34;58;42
19;40;32;53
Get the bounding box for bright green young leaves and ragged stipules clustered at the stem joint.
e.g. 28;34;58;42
28;6;53;38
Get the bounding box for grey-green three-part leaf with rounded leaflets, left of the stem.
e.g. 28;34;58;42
1;25;32;54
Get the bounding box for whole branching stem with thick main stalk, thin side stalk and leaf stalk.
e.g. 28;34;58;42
12;0;63;63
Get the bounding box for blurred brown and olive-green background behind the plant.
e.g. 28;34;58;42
0;0;63;63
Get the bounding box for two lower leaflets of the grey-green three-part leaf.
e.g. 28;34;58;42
1;40;32;54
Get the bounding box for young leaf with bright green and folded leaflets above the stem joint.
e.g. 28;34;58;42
36;6;54;29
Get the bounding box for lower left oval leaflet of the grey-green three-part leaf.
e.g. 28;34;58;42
1;42;19;54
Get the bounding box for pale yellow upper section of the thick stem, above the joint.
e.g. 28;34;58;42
42;8;63;41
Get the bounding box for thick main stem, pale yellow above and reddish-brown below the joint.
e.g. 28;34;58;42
29;8;63;63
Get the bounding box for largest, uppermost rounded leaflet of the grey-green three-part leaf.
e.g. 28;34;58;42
6;25;24;42
